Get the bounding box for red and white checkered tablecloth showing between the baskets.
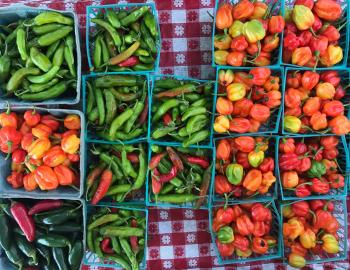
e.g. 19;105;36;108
0;0;350;270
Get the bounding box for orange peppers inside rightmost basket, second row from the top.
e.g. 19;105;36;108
283;70;350;135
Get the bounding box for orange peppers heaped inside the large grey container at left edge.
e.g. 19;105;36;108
0;107;81;191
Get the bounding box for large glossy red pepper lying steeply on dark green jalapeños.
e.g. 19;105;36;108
11;202;35;242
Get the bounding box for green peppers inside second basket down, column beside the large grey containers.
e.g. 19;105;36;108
85;74;148;141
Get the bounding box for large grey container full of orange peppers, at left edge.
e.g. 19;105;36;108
0;107;84;198
